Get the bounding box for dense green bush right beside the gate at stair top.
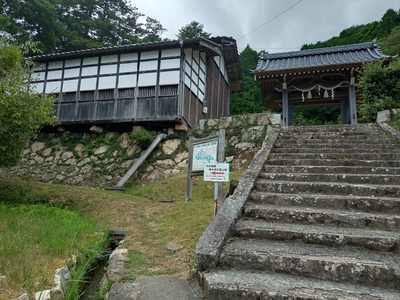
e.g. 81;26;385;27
359;60;400;122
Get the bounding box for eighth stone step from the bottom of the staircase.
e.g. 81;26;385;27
265;158;400;168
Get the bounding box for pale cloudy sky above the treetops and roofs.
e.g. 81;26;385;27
130;0;400;53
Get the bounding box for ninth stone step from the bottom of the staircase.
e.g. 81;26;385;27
269;149;400;161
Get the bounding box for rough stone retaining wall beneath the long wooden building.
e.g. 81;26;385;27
0;113;280;187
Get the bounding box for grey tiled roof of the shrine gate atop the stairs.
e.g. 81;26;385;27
252;40;395;75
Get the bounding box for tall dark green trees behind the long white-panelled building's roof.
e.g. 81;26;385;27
0;0;166;53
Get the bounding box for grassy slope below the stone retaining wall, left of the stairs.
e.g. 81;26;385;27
0;171;243;299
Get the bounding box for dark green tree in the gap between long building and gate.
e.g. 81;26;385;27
231;45;263;114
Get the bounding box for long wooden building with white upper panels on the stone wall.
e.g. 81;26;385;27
32;37;243;130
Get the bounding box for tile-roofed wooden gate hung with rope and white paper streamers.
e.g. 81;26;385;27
252;40;395;126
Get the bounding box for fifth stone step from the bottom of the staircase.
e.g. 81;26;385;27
247;191;400;214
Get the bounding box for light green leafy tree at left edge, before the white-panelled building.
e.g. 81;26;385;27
0;39;55;167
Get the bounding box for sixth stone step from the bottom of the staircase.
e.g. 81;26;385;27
255;179;400;198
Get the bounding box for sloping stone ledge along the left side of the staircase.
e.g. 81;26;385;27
196;133;278;271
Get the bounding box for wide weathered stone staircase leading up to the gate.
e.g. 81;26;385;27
202;124;400;300
